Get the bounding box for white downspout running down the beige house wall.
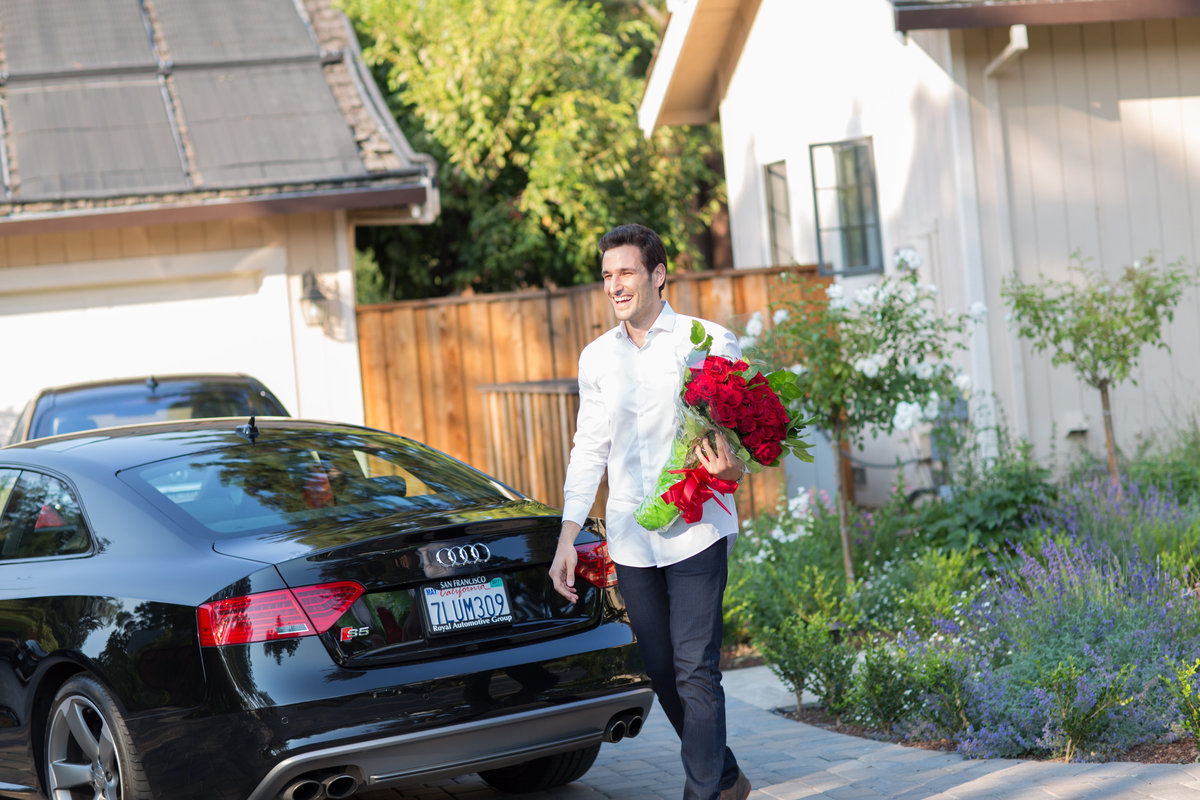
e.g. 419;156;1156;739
983;25;1030;438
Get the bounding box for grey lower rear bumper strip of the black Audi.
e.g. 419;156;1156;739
247;687;653;800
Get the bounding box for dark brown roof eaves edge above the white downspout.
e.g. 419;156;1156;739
892;0;1200;32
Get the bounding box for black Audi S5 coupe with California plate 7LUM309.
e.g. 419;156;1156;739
0;419;652;800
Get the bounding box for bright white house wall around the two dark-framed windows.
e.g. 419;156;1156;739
720;0;970;501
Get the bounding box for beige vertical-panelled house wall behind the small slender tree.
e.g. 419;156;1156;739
960;19;1200;470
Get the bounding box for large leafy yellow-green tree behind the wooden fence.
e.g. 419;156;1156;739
343;0;724;297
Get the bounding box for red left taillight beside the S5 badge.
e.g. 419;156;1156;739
196;581;364;648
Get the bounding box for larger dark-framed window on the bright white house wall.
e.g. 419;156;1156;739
809;137;883;275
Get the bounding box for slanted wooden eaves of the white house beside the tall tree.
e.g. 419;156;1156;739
637;0;762;136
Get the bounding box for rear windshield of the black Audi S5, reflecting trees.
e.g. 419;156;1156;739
121;434;518;534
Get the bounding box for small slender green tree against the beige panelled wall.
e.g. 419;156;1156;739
1001;253;1196;488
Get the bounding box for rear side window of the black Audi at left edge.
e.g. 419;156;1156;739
0;469;91;560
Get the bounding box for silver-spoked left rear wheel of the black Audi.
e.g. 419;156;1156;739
42;675;150;800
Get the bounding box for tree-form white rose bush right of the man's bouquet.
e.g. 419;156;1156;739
742;271;986;583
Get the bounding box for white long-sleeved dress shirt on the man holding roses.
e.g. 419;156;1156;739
563;301;742;567
